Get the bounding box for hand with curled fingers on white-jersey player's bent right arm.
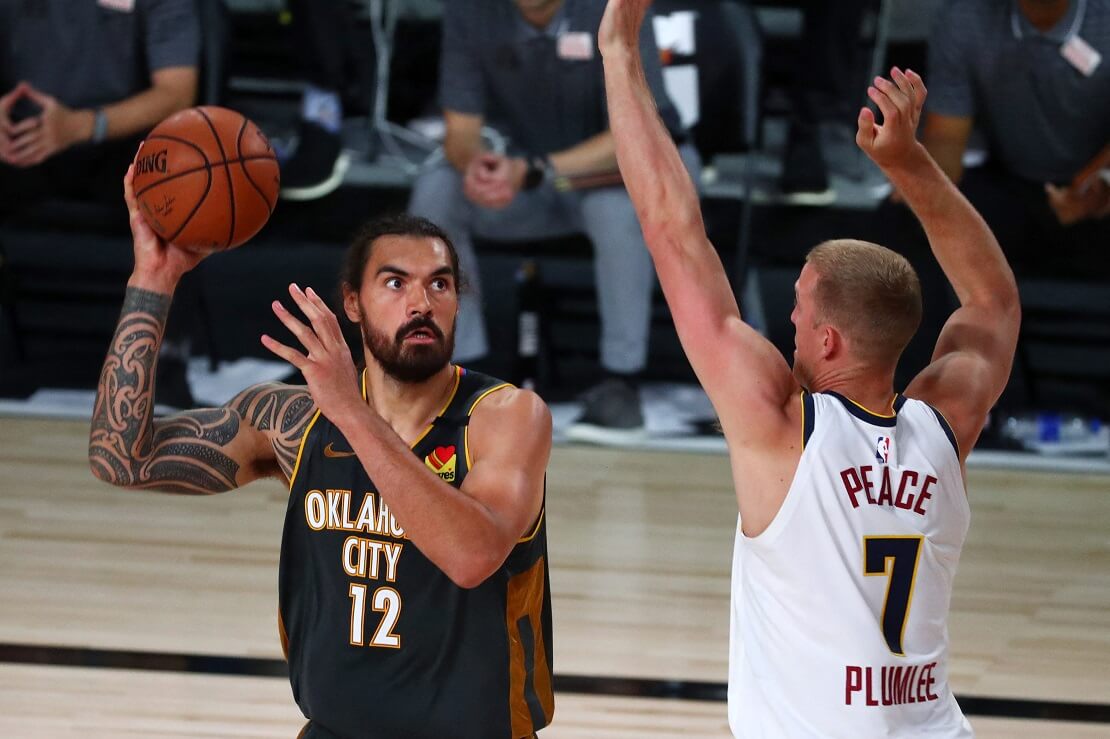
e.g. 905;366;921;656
856;67;928;168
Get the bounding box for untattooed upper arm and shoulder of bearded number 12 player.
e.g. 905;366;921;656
462;388;552;545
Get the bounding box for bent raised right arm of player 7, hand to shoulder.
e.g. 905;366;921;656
856;68;1021;457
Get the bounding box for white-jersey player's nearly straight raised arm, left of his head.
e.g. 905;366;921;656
598;0;798;437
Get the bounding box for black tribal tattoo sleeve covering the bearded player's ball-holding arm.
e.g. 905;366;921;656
89;287;315;494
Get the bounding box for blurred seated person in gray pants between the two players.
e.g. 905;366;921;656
410;0;699;443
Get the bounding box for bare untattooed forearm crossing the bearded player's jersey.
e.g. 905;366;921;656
332;404;518;587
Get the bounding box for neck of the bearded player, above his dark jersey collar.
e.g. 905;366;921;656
365;361;456;442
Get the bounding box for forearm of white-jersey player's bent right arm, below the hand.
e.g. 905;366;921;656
885;144;1018;307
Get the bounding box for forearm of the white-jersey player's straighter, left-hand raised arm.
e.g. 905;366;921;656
605;48;704;243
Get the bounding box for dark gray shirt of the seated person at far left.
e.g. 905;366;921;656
0;0;200;108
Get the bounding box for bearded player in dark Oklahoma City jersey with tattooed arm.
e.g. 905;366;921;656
89;168;554;739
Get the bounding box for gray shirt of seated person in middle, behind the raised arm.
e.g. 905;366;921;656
440;0;683;154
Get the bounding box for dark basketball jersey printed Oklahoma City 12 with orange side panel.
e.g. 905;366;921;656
279;367;554;739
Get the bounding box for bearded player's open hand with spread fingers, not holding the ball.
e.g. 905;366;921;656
262;283;363;428
